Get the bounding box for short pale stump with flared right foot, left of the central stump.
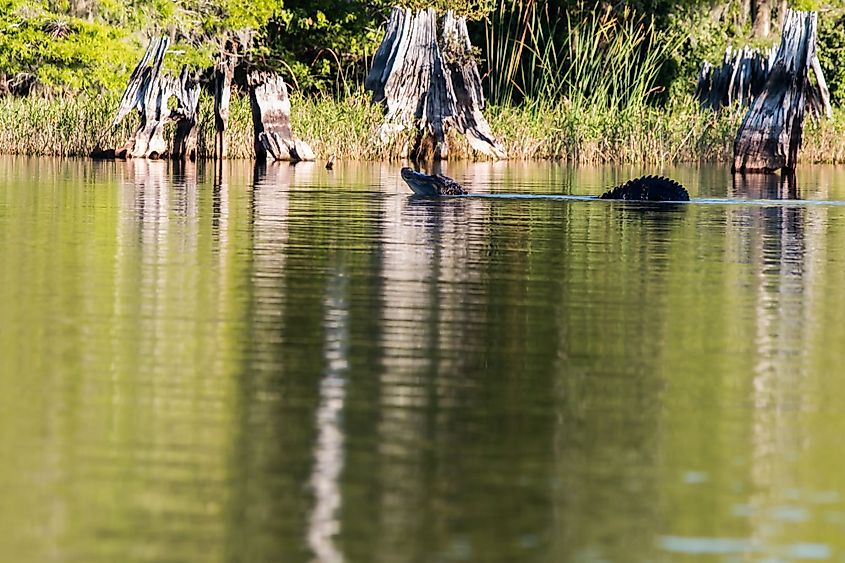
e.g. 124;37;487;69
247;71;315;162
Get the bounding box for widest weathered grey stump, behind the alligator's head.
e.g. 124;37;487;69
365;7;507;159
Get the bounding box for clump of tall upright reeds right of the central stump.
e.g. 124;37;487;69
485;0;680;112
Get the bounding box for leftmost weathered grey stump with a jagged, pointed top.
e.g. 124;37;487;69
108;37;200;158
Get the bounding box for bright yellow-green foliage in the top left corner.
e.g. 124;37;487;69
0;0;282;93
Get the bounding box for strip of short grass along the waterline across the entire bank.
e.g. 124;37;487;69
0;93;845;164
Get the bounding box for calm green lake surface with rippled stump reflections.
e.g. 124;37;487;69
0;158;845;563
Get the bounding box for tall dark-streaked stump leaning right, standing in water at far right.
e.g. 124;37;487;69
733;10;817;172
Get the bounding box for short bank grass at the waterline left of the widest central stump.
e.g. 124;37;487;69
0;88;408;160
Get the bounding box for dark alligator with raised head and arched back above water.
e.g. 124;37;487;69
402;167;689;201
